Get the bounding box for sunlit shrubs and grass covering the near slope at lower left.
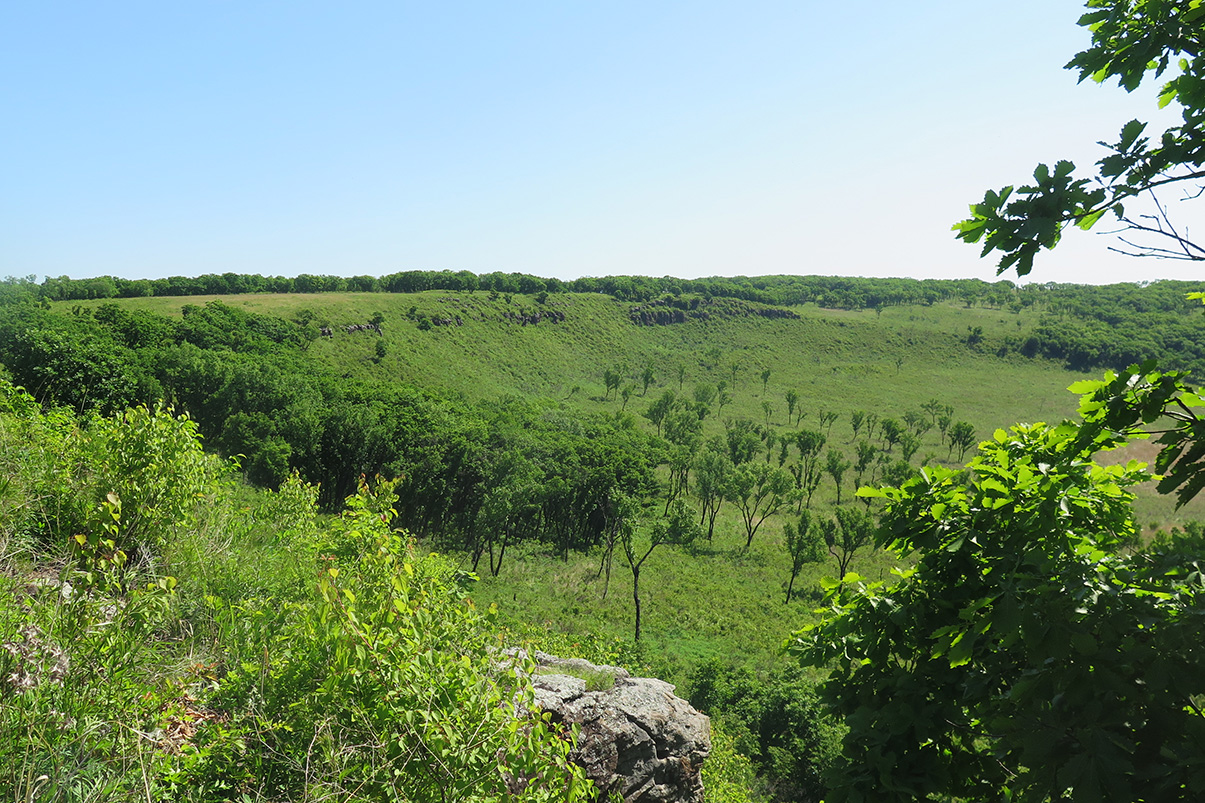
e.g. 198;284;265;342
0;397;592;802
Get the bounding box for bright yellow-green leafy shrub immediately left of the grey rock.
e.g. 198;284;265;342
176;483;592;802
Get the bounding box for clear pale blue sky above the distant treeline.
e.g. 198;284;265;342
0;0;1205;283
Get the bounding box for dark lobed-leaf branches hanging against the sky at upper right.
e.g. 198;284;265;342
953;0;1205;276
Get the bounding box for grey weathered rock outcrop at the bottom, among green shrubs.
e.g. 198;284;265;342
533;652;711;803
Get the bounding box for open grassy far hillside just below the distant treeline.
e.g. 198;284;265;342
89;291;1085;419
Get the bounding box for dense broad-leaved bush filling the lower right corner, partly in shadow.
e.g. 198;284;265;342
790;414;1205;802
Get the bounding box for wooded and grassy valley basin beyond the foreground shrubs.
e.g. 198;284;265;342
9;279;1200;789
